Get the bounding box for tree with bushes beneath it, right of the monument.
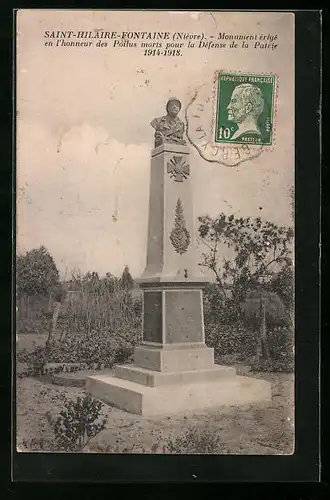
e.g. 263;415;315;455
199;214;294;371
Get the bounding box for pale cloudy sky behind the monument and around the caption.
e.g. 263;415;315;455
17;10;294;277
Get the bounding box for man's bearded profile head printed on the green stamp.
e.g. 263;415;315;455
227;83;265;124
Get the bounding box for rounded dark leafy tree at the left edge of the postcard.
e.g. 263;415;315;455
16;246;59;296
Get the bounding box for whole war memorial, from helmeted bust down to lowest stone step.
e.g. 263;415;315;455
86;98;271;415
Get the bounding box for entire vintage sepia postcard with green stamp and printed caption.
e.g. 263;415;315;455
16;10;295;455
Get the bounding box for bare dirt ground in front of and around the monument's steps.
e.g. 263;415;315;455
17;373;294;455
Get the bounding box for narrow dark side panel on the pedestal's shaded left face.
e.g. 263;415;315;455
143;292;162;342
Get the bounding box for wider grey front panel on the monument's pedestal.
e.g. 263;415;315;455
165;290;203;344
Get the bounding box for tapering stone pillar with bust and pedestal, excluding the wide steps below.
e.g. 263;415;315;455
135;98;213;372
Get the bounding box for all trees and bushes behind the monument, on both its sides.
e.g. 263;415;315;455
17;209;294;375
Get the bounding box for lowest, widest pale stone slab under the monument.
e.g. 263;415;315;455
86;367;271;416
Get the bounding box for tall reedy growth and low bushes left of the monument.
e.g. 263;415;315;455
17;254;142;368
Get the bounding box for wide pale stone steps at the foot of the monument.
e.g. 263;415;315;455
86;365;271;416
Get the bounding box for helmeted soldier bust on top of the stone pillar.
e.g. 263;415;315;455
150;98;187;148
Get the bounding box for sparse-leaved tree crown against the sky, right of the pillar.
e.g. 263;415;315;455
199;213;293;306
